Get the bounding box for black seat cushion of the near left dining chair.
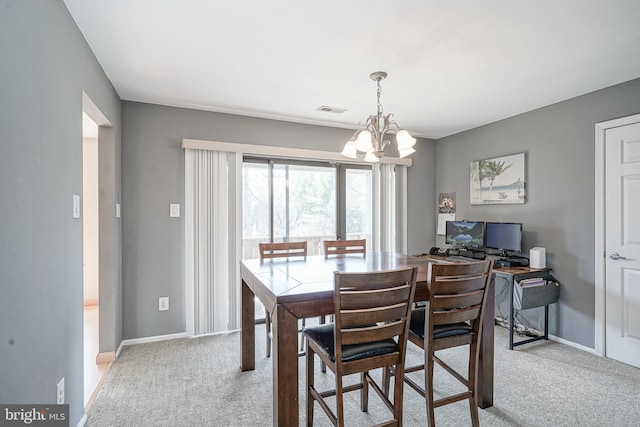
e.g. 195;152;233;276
304;323;398;362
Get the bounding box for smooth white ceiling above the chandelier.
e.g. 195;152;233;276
64;0;640;138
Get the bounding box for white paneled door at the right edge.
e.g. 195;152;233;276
595;115;640;367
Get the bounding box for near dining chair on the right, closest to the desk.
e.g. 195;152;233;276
383;260;493;427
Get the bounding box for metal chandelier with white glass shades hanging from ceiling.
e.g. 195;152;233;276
340;71;416;162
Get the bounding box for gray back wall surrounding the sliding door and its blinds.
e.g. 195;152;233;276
122;102;435;339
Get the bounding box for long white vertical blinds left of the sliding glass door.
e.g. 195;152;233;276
184;149;242;336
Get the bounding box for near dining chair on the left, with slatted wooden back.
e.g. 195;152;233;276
303;267;418;426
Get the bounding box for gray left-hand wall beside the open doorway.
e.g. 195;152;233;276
0;0;120;425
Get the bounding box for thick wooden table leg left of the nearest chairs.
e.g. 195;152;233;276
271;305;299;427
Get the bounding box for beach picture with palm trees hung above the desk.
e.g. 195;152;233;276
469;153;527;205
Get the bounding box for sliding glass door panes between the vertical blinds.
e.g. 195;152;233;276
243;158;372;258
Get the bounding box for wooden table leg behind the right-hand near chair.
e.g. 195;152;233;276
477;278;496;409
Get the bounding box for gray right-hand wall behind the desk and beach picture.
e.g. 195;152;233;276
436;79;640;348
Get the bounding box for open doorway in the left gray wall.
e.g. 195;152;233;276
79;92;121;408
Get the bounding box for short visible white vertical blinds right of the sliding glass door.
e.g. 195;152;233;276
373;163;407;253
